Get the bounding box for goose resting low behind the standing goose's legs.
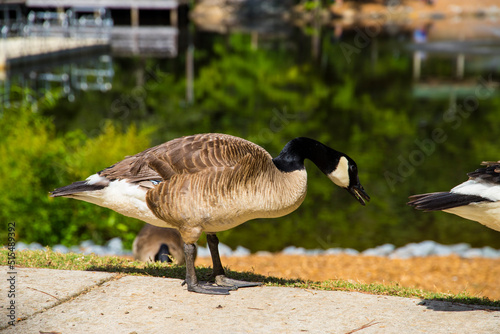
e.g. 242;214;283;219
132;224;191;265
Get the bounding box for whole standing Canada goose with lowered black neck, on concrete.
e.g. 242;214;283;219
51;134;370;294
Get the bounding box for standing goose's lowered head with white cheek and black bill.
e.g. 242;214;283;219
325;154;370;205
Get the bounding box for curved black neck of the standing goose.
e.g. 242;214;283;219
273;137;342;174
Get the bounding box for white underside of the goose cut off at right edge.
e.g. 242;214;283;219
443;202;500;231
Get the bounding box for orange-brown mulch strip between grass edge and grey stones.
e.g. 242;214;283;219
196;254;500;300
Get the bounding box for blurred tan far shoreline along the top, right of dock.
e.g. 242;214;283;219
190;0;500;41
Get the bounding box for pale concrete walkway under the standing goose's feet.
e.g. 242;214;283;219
0;267;500;334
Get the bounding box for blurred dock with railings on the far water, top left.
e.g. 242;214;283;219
0;0;188;73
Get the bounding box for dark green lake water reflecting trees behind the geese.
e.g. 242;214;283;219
3;18;500;250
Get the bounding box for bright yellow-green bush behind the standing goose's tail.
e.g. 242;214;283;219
0;100;150;245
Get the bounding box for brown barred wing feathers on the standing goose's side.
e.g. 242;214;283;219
146;135;277;232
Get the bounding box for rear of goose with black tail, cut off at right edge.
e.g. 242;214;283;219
408;161;500;231
